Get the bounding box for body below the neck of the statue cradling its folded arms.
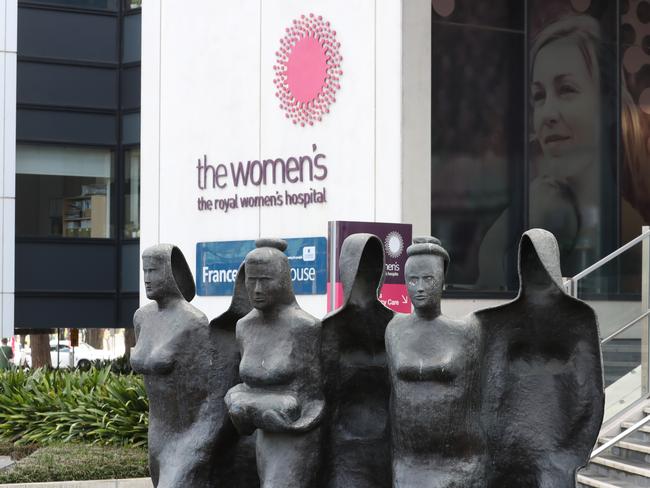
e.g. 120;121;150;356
225;303;324;488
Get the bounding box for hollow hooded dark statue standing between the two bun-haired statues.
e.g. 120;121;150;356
322;234;394;488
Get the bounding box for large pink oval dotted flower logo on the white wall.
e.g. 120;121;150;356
273;14;343;127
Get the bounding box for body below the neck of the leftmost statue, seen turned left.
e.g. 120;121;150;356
131;292;227;487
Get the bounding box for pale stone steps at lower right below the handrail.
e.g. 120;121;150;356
577;400;650;488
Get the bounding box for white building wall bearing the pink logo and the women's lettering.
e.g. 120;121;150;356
141;0;431;317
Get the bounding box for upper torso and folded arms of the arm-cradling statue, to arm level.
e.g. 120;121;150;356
226;304;323;433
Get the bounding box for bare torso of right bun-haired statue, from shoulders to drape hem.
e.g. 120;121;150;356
386;315;482;456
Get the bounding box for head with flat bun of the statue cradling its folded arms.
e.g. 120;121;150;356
244;239;295;312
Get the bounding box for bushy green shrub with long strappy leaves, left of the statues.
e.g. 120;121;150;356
0;367;149;446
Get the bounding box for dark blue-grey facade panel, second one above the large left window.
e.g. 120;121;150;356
17;61;117;109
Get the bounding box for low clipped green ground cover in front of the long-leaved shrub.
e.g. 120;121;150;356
0;444;149;483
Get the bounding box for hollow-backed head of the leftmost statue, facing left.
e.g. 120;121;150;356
142;244;195;302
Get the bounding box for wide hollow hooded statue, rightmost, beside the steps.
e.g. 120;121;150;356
475;229;605;488
